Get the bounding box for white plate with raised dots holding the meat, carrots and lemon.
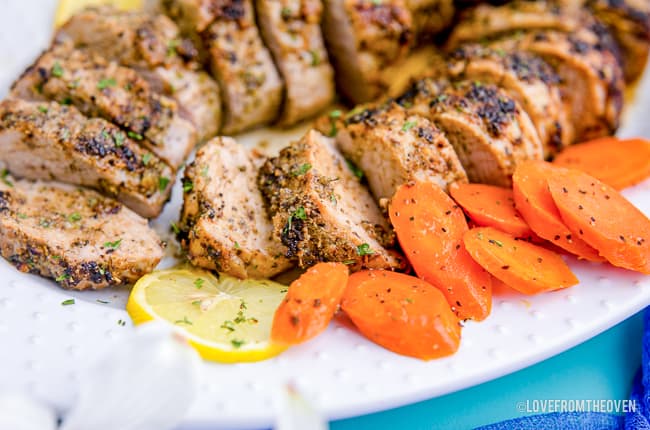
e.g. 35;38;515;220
0;0;650;428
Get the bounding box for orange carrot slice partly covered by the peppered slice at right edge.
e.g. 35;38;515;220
512;161;604;261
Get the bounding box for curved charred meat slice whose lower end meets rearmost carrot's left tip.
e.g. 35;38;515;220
444;44;573;157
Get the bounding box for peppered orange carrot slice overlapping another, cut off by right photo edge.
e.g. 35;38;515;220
548;169;650;274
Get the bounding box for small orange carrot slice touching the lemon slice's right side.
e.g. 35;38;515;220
271;263;348;345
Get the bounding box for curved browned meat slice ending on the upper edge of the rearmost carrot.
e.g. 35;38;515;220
492;23;625;141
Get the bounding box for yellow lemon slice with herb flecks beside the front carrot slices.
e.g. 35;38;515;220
126;267;287;363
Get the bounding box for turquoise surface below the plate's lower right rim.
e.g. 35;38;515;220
331;314;643;430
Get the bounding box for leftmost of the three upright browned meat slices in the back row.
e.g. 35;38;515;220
202;0;283;134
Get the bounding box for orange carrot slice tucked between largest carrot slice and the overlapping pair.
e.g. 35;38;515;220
449;183;534;239
